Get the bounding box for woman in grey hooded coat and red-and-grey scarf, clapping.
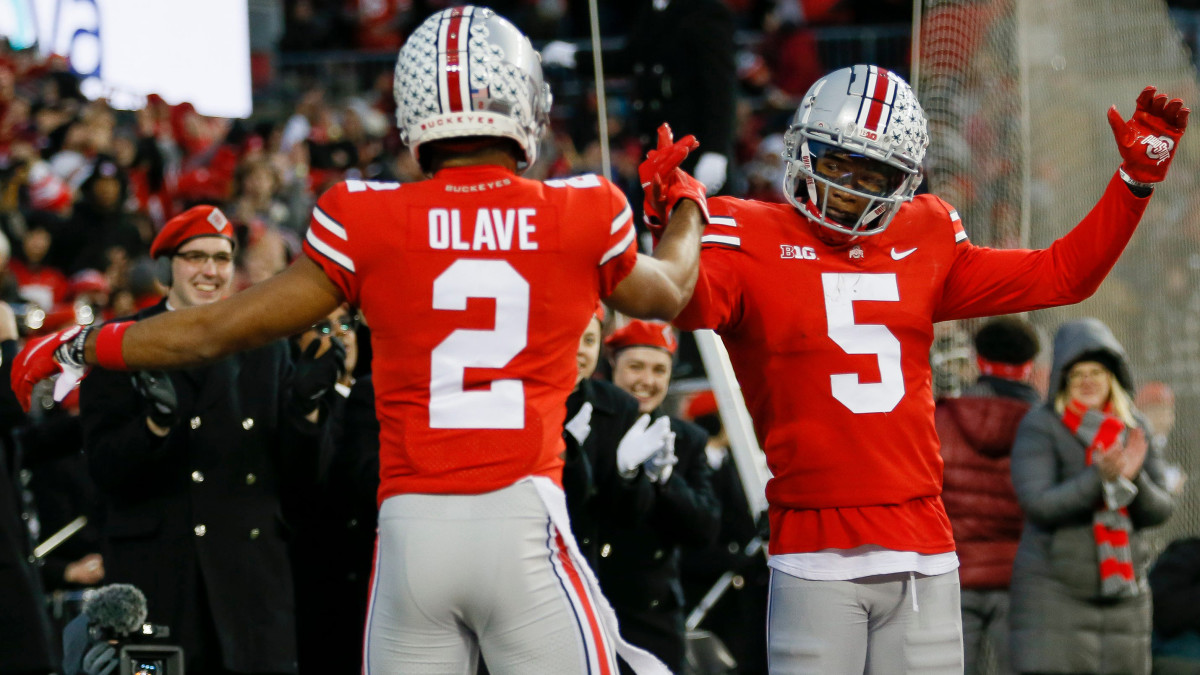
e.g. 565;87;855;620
1010;318;1174;675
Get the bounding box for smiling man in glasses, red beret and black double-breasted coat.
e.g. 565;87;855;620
80;207;341;675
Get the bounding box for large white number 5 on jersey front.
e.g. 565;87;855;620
821;273;904;413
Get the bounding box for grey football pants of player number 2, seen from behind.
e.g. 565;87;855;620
364;483;617;675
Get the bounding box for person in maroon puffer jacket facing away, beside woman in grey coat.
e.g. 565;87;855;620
934;317;1039;675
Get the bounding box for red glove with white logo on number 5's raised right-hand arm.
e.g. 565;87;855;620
1109;86;1192;185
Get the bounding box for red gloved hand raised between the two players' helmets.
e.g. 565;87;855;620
637;123;708;241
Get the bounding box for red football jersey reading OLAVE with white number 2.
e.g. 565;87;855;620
305;166;637;501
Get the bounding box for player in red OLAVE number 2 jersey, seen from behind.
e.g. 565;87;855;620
13;6;704;675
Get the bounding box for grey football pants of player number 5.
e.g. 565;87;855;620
767;569;962;675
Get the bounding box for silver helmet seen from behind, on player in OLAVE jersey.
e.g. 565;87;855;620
394;5;551;168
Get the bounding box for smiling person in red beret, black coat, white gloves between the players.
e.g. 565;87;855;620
598;321;721;673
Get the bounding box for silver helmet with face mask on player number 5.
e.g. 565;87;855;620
784;65;929;235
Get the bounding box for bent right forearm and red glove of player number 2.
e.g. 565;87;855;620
605;124;708;321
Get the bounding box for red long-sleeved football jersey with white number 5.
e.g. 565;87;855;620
676;171;1148;554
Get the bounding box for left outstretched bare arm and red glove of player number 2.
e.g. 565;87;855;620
12;257;343;410
